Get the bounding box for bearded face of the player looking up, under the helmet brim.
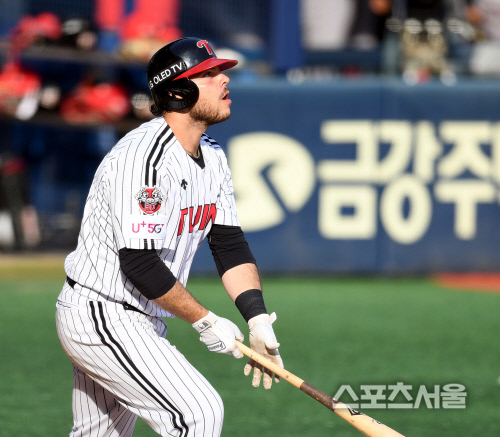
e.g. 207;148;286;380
190;67;231;126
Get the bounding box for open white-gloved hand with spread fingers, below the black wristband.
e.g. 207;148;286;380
243;313;283;390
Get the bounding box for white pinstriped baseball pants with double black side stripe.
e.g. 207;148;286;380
56;301;224;437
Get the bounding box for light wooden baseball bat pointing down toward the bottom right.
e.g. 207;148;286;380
238;341;404;437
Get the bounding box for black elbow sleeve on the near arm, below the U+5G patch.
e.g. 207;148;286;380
118;248;177;299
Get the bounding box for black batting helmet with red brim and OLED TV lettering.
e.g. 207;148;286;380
146;38;238;115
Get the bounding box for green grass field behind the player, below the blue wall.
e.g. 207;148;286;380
0;255;500;437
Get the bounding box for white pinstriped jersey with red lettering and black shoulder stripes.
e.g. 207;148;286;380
59;118;239;317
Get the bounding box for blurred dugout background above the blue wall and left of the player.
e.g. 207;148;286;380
0;0;500;258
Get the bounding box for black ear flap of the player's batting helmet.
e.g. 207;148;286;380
153;78;200;111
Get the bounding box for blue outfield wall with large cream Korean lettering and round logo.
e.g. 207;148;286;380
193;80;500;274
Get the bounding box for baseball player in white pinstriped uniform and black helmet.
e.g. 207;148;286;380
56;38;283;437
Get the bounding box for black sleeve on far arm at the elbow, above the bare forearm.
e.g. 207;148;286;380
208;225;256;277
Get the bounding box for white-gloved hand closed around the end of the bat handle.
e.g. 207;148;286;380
193;311;244;358
